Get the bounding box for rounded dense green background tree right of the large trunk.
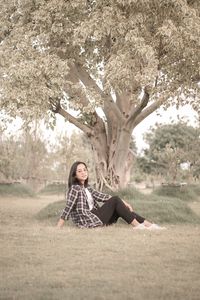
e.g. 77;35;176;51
138;122;200;181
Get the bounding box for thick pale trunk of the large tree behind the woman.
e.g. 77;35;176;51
88;119;134;190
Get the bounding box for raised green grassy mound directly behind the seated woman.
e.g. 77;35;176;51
37;184;200;226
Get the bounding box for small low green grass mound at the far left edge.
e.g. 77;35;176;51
0;183;35;197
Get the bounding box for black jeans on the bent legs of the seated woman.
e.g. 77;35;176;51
91;196;145;225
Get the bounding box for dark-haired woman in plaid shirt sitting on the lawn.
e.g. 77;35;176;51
57;161;163;229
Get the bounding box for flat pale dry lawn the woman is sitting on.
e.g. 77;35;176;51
0;196;200;300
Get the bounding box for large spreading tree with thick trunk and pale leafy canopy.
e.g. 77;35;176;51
0;0;200;187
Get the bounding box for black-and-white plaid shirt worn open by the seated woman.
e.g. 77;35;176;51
61;185;111;228
